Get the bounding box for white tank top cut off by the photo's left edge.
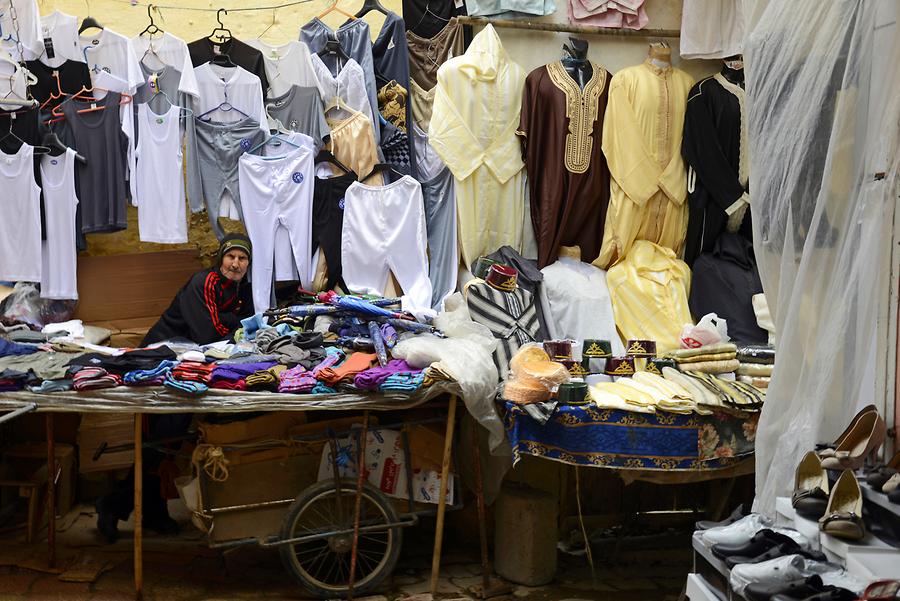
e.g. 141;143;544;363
0;144;41;282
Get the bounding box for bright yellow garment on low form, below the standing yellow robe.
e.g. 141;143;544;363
606;240;693;354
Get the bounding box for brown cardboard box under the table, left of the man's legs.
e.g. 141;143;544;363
78;413;134;473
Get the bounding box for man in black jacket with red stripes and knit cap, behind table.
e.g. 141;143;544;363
96;234;253;543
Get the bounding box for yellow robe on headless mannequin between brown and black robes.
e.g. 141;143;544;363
594;60;693;269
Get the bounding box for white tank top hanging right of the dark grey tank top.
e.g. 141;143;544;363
135;104;188;244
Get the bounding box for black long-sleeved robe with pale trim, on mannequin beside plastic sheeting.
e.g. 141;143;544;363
681;67;753;265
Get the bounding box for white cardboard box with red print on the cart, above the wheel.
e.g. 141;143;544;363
318;430;454;505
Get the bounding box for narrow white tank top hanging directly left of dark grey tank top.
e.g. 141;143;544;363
41;148;78;300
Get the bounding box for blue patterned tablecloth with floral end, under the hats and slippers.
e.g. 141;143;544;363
503;402;759;471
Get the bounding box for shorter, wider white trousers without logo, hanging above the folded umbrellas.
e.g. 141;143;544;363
341;175;431;312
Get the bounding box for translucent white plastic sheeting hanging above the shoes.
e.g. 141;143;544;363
744;0;900;514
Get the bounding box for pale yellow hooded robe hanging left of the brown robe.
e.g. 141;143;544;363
428;25;525;270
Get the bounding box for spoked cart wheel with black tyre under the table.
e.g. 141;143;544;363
279;480;403;599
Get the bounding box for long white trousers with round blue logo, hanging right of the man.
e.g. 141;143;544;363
239;146;315;313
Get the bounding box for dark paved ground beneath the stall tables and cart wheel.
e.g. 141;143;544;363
0;507;691;601
